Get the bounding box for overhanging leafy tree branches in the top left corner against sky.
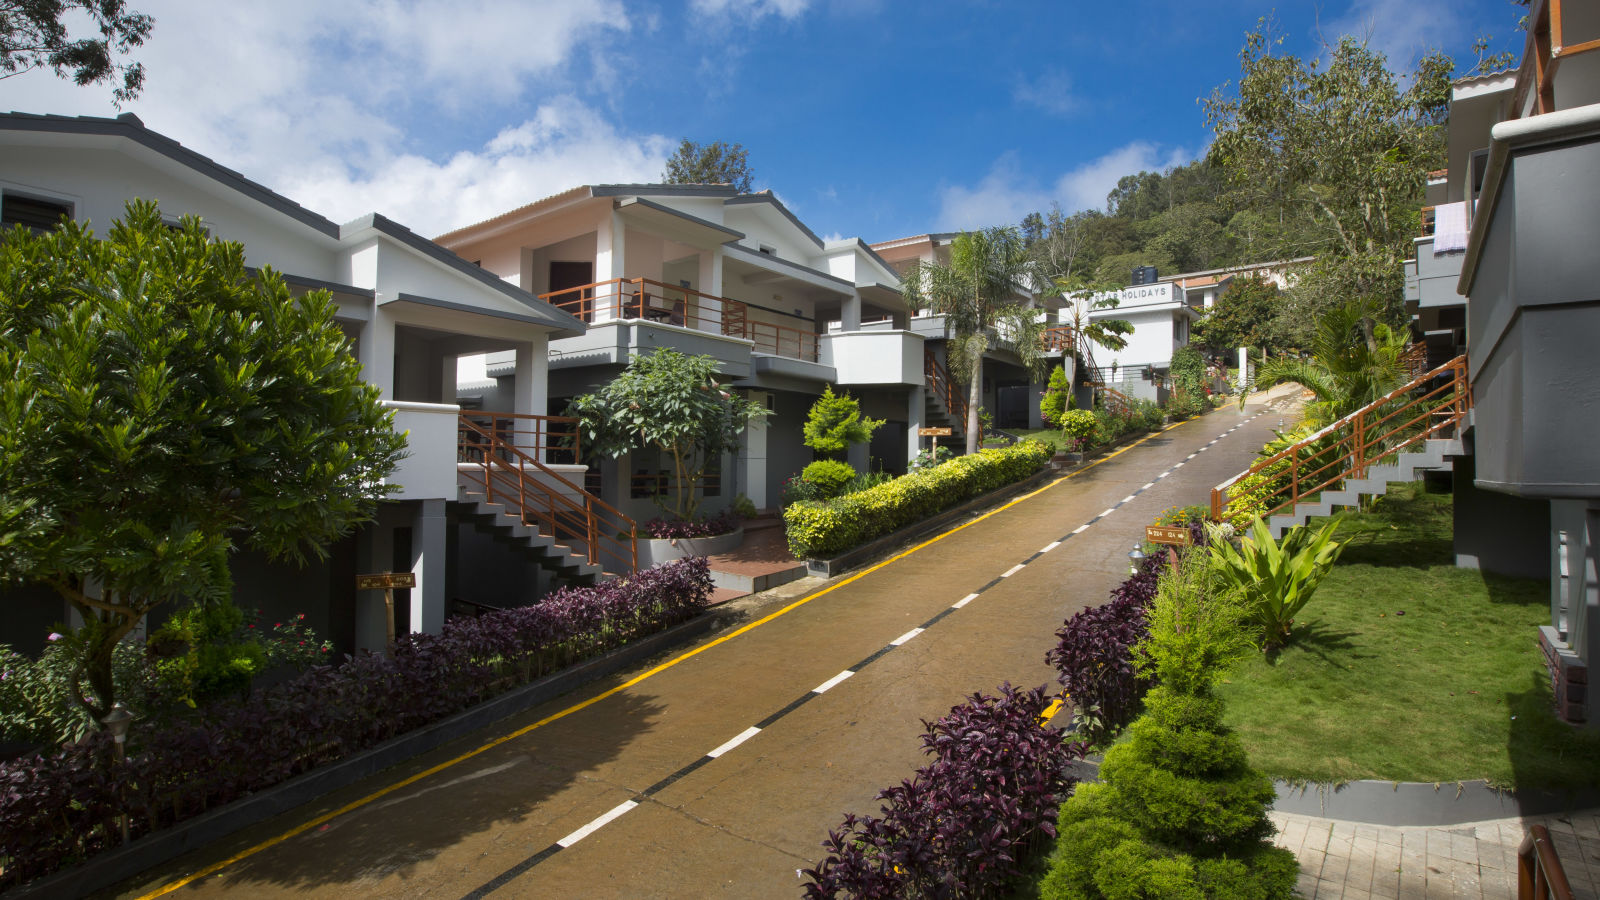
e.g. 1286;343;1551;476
0;0;155;102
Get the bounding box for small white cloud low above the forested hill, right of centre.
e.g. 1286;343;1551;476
938;141;1190;229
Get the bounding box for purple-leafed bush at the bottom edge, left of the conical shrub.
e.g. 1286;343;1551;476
802;684;1085;898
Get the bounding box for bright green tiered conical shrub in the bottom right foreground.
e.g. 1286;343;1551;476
1040;552;1299;900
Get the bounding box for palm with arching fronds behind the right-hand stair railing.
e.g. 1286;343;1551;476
1240;299;1410;428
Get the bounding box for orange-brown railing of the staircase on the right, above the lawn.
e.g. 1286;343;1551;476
1211;356;1472;522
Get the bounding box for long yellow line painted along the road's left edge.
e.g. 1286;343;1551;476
138;420;1194;900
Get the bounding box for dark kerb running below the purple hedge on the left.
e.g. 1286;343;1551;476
0;612;722;900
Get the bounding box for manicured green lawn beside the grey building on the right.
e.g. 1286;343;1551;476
1222;484;1600;788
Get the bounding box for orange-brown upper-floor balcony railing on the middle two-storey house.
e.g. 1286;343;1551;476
539;279;818;362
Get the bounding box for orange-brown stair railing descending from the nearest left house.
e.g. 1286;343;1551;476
459;413;638;575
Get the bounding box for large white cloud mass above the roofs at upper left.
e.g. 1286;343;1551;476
5;0;670;234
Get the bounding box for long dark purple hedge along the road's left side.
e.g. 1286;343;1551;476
0;557;712;889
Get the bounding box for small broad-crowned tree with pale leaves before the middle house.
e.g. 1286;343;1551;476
568;348;768;519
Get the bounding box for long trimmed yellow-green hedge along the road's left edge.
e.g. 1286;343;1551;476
784;440;1051;559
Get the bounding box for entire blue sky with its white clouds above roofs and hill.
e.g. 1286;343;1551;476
0;0;1523;242
